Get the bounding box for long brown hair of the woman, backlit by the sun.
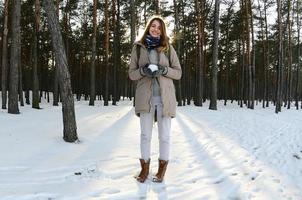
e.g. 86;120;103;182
139;15;170;51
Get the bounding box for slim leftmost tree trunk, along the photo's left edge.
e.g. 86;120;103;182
1;0;9;109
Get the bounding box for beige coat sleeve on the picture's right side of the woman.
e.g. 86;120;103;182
165;45;182;80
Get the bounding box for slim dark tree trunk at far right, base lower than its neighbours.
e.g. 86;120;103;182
275;0;283;113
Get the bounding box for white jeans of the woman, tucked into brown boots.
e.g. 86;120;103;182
140;97;171;161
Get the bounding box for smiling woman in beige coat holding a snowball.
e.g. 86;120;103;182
129;16;181;183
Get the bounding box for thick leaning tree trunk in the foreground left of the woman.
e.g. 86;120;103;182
43;0;78;142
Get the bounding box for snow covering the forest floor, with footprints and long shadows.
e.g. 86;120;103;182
0;97;302;200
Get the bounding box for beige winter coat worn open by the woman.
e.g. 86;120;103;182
129;42;181;117
